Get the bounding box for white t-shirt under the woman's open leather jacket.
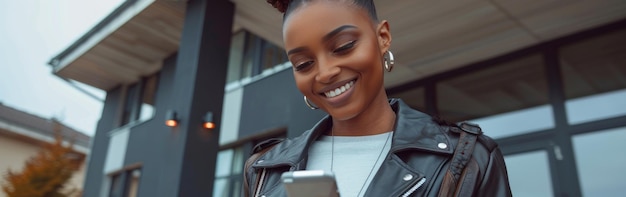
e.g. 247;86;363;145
307;132;393;196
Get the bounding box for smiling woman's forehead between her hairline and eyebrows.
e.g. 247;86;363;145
283;1;373;50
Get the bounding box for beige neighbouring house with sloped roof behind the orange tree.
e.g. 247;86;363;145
0;103;91;197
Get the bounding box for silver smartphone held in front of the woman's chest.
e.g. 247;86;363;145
281;170;339;197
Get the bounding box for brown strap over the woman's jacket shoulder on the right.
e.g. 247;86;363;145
439;122;482;197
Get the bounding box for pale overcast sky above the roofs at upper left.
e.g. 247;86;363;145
0;0;123;136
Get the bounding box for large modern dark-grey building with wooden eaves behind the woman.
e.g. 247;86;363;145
50;0;626;197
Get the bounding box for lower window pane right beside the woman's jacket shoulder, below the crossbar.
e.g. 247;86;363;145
504;150;554;197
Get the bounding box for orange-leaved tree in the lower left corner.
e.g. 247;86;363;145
2;120;84;197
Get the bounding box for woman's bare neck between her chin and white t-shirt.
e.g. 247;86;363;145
332;90;396;136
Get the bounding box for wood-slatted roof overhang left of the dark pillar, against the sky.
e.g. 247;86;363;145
50;0;186;90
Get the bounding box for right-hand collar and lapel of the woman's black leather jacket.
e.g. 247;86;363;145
365;99;453;196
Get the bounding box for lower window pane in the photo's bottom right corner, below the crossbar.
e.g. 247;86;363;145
573;127;626;196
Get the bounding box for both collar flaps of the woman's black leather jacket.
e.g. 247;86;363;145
253;99;453;168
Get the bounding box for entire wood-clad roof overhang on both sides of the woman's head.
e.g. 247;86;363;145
51;0;626;90
